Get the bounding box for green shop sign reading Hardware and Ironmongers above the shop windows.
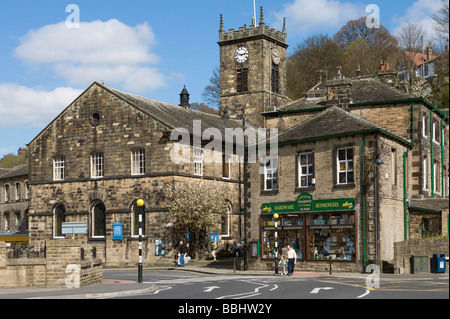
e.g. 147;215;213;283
261;193;355;214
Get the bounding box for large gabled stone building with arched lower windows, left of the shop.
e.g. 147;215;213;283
28;82;248;266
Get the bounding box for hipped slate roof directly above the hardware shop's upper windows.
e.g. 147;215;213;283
278;106;409;144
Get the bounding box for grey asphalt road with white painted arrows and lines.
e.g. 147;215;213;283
104;270;449;300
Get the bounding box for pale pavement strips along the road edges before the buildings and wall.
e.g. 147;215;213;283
0;265;449;299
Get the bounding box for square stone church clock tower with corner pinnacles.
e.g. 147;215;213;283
218;7;288;127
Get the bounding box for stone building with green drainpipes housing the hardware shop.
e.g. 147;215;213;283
244;70;449;271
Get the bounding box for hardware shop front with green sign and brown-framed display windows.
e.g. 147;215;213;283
261;193;356;262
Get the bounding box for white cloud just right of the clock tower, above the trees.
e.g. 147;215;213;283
275;0;367;33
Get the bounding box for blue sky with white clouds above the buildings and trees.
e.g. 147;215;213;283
0;0;440;158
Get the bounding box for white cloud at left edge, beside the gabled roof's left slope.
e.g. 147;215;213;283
0;83;82;128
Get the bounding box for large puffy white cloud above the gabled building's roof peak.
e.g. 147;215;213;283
14;19;166;93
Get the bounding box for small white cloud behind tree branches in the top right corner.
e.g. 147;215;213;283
392;0;441;41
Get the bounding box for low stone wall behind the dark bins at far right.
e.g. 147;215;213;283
394;238;449;274
